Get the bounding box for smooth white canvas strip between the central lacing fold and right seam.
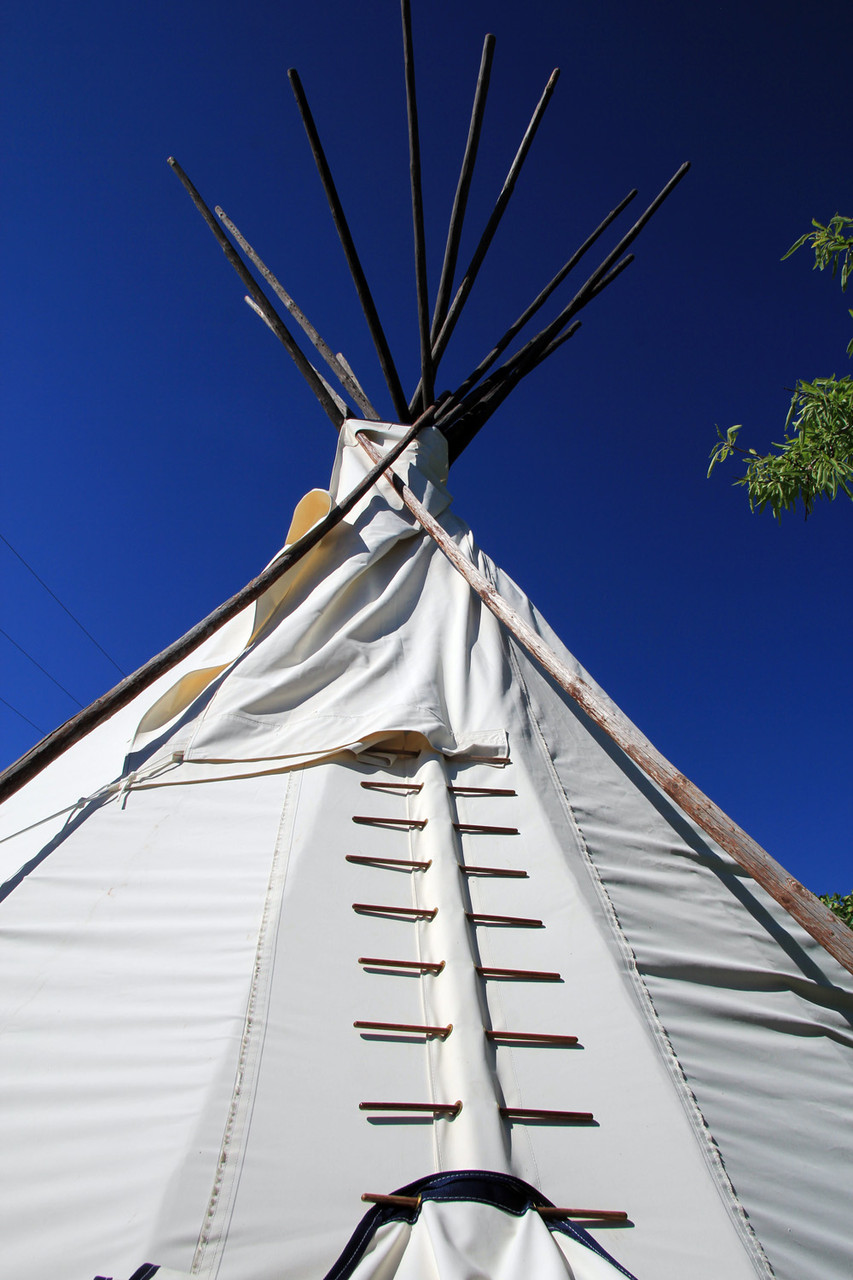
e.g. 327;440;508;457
438;757;754;1280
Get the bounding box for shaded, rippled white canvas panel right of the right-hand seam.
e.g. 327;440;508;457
484;571;853;1280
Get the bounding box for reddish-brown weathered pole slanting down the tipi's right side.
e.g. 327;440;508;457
359;434;853;973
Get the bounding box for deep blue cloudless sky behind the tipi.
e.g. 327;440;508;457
0;0;853;892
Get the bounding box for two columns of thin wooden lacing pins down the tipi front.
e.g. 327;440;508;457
347;760;628;1222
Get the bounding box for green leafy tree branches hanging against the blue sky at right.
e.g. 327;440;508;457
708;214;853;520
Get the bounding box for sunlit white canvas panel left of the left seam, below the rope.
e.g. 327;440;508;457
0;778;289;1280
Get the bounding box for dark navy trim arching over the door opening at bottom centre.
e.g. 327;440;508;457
322;1169;635;1280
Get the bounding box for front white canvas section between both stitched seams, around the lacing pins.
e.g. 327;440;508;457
180;747;754;1280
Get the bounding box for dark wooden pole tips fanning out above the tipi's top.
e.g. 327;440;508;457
163;26;689;462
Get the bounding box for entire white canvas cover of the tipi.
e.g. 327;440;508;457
0;422;853;1280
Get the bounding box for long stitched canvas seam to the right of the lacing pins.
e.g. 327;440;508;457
502;614;775;1280
